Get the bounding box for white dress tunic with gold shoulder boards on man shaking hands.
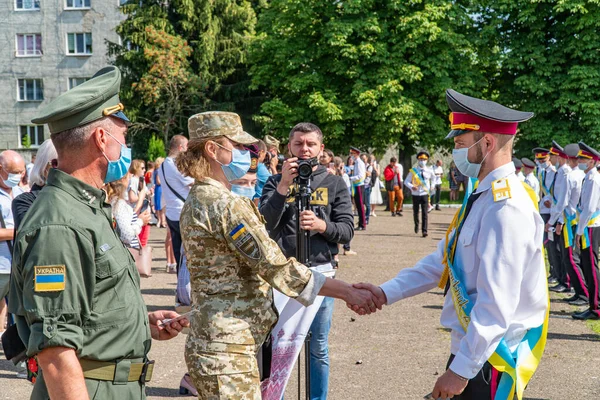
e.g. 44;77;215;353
381;162;548;379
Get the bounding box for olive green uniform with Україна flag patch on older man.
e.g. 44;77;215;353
9;170;151;399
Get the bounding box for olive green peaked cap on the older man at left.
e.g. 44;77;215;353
31;66;130;133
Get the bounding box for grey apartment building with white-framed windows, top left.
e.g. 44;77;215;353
0;0;125;153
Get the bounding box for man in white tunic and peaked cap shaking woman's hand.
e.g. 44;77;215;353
357;90;548;400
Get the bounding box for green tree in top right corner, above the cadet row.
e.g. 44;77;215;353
470;0;600;155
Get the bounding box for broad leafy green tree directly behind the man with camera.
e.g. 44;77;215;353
251;0;486;159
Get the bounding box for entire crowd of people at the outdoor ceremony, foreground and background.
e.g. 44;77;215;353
0;67;600;400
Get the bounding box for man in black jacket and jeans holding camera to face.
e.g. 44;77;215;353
260;122;354;400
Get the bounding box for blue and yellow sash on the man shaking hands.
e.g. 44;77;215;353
439;179;550;400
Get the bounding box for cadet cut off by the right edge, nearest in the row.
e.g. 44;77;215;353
573;142;600;320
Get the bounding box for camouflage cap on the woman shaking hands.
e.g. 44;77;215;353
188;111;257;144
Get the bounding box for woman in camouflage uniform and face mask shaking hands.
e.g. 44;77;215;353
177;112;381;400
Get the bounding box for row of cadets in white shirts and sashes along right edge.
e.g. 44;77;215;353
513;141;600;320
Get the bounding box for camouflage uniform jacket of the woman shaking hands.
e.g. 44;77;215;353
180;178;325;375
